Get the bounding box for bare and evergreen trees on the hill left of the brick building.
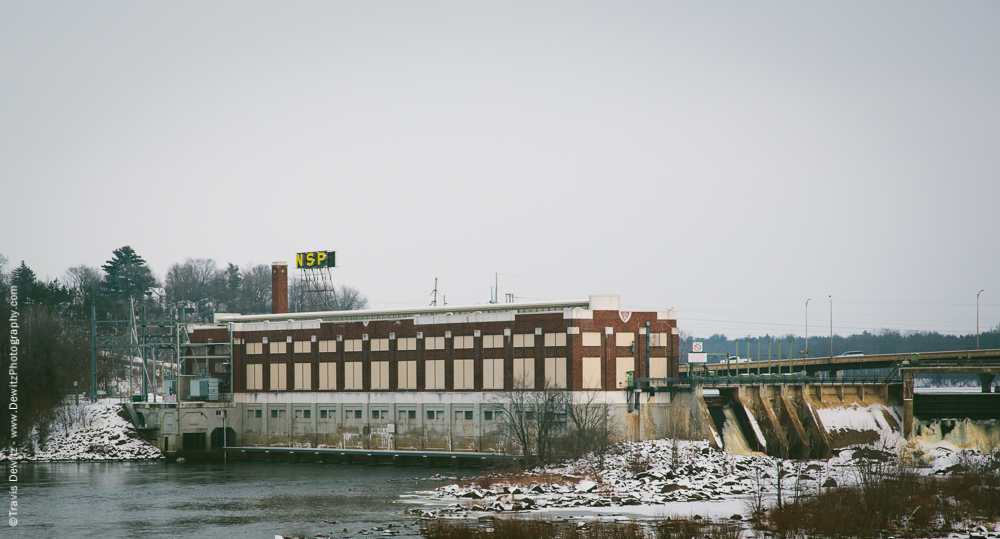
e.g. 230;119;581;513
0;246;368;447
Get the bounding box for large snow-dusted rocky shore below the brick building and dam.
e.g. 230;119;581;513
411;440;851;517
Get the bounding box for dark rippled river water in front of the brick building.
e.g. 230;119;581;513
10;461;450;539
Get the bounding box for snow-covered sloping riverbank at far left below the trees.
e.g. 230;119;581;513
0;403;163;461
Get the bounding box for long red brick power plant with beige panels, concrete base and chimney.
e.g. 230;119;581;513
135;263;679;451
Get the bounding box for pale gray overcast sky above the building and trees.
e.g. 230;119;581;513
0;1;1000;337
